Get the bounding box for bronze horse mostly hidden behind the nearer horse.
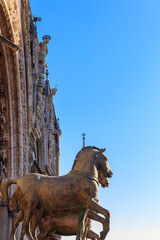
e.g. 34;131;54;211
30;171;109;240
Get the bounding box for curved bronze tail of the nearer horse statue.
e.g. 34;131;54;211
1;178;17;204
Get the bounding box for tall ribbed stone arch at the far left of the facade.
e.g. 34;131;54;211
0;0;23;177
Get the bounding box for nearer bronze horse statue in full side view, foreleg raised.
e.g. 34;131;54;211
1;147;113;240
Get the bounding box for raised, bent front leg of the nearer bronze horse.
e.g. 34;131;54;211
82;199;110;240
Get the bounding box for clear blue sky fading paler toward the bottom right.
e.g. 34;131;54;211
30;0;160;240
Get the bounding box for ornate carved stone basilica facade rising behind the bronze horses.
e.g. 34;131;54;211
0;0;61;240
